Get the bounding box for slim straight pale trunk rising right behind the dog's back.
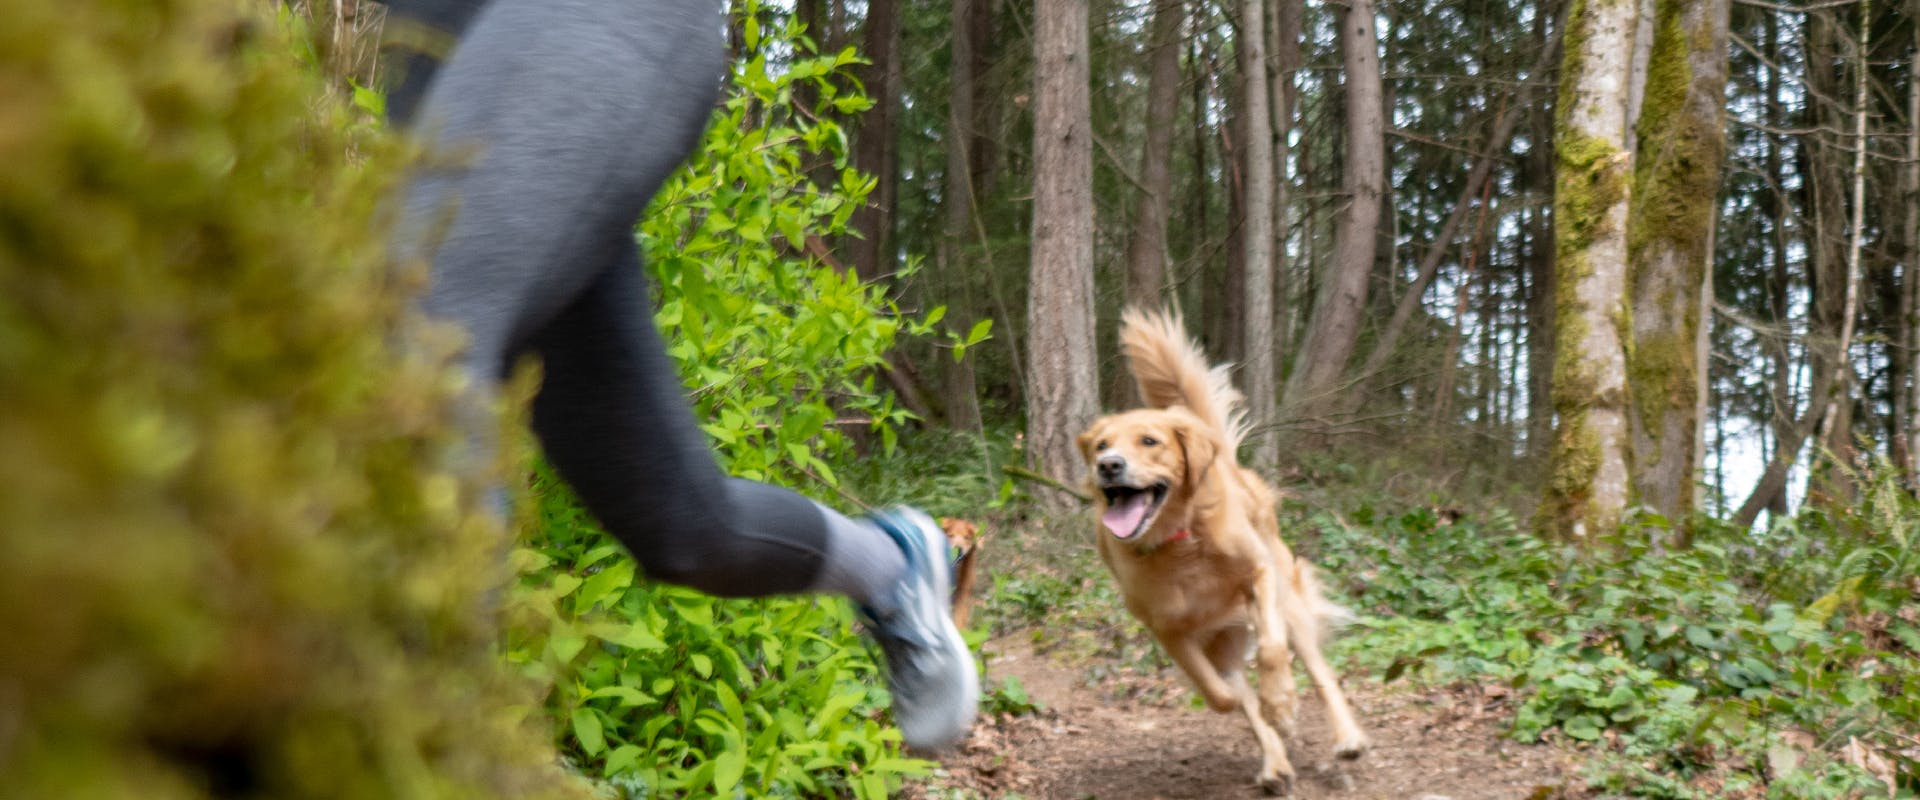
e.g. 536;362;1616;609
1238;0;1281;470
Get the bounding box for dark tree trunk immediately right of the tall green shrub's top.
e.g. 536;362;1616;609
849;0;900;280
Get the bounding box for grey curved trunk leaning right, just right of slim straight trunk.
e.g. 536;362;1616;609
1286;0;1386;422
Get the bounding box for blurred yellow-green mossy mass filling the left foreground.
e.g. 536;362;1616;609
0;0;578;798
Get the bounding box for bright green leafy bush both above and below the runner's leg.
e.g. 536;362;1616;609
509;4;935;798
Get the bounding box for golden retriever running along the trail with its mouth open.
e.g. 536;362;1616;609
1079;309;1369;794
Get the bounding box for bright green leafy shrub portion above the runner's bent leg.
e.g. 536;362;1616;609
639;2;937;487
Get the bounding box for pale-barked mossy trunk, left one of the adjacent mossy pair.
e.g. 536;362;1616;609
1536;0;1638;541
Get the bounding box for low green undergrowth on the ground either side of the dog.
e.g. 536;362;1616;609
876;429;1920;798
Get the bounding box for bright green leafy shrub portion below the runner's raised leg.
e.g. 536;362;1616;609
509;464;927;798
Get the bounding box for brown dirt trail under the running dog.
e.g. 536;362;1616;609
924;633;1571;800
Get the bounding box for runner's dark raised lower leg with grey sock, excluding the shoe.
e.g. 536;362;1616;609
532;234;906;610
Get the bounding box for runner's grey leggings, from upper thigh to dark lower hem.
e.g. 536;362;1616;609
388;0;828;597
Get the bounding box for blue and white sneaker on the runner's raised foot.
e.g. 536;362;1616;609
860;506;979;750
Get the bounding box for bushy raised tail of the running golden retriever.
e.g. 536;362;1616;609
1119;307;1248;453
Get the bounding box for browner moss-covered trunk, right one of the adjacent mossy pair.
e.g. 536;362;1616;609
1628;0;1728;520
